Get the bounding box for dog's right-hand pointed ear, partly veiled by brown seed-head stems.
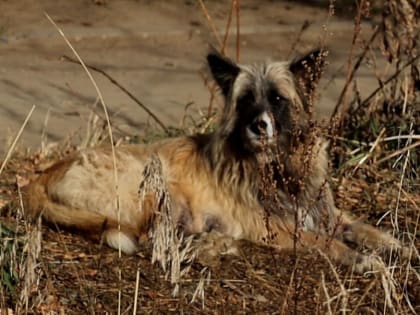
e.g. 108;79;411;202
289;49;327;96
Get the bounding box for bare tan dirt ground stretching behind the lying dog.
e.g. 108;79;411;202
0;0;376;155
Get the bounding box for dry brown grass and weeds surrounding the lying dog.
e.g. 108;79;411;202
0;0;420;315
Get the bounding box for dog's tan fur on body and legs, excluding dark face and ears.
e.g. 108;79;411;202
24;50;401;272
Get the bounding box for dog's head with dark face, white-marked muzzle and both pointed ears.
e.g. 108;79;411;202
207;51;324;153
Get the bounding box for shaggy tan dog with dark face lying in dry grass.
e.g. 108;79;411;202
24;50;403;272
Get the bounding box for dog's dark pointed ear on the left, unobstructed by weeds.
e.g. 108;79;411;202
207;47;240;97
